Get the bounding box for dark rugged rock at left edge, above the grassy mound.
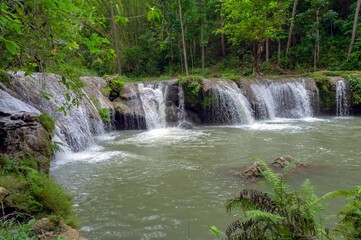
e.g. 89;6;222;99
0;110;52;173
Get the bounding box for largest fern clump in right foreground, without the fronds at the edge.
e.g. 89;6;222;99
219;161;324;239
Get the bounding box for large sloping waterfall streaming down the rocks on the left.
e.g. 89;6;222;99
7;72;104;151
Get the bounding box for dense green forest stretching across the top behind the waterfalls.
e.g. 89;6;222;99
0;0;361;78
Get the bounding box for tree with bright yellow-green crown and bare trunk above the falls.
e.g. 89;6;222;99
219;0;287;75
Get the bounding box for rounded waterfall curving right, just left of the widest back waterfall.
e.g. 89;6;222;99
211;81;253;125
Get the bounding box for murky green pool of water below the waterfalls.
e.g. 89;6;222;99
51;118;361;239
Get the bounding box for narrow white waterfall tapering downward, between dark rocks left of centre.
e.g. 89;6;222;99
138;83;167;129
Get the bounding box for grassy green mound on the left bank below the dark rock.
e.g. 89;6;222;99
0;156;77;228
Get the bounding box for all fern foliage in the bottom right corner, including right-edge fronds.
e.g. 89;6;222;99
210;161;361;239
